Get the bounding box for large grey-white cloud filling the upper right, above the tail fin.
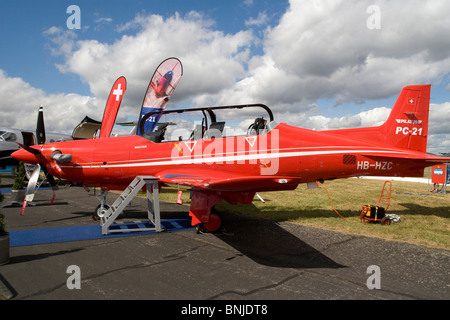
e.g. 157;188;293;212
212;0;450;112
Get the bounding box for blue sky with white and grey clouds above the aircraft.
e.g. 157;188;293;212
0;0;450;152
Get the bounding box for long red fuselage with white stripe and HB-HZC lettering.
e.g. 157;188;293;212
20;123;430;191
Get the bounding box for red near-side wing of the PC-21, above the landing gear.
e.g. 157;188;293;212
156;169;301;192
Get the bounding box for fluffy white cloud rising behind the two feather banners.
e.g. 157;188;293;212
50;12;252;122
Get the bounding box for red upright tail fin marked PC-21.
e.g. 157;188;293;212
380;85;431;152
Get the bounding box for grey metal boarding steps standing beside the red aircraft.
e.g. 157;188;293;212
100;176;163;235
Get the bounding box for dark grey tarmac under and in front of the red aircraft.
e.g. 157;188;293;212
0;174;450;304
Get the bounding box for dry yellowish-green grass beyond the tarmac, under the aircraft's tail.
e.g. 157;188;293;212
156;179;450;249
